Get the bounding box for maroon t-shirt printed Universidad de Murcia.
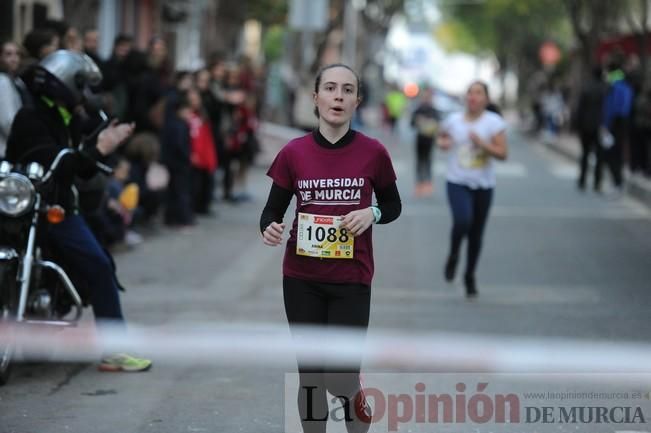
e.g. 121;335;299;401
267;132;396;286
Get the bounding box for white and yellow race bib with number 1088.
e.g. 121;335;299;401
296;212;354;259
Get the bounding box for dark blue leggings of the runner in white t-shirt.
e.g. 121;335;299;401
448;182;493;277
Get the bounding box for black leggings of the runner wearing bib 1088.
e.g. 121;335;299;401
283;277;371;433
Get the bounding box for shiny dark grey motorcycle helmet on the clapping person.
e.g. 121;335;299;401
23;50;102;110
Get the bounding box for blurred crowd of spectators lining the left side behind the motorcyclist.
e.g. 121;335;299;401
0;21;262;247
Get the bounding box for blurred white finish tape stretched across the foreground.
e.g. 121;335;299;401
0;323;651;377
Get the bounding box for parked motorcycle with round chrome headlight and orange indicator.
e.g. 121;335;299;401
0;149;93;385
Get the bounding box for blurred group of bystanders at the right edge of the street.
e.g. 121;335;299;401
529;51;651;196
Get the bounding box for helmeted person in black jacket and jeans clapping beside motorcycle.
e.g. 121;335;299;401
6;50;151;371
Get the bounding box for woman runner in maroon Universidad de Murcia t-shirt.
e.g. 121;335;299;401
260;64;401;433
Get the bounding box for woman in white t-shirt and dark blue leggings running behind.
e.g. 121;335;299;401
437;81;508;297
